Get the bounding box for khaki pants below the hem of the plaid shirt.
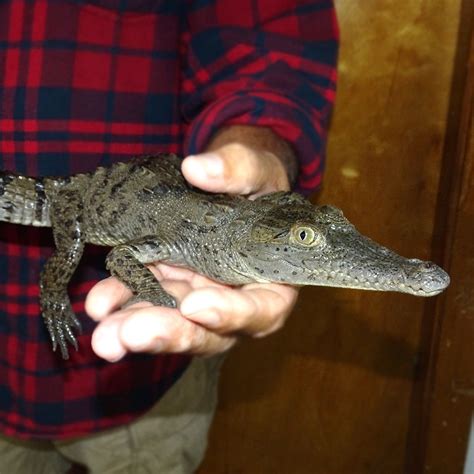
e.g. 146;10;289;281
0;356;223;474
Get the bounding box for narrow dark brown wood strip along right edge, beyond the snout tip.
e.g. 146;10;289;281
411;11;474;474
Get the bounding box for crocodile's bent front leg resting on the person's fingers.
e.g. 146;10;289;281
107;238;176;308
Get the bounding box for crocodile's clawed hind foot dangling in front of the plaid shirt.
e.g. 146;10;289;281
41;297;81;359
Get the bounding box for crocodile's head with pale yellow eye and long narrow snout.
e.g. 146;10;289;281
236;193;449;296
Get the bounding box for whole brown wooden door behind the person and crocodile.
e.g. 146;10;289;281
196;0;474;474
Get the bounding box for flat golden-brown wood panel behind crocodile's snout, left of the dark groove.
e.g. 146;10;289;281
200;0;460;474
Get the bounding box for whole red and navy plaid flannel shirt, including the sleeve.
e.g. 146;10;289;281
0;0;338;438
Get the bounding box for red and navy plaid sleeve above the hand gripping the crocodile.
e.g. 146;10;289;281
181;0;339;194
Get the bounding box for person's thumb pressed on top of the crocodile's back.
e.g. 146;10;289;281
182;145;289;195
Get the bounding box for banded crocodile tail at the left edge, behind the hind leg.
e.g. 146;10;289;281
0;171;67;227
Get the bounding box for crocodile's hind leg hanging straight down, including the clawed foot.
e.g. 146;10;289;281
40;191;84;359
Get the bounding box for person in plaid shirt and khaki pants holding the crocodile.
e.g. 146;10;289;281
0;0;338;474
